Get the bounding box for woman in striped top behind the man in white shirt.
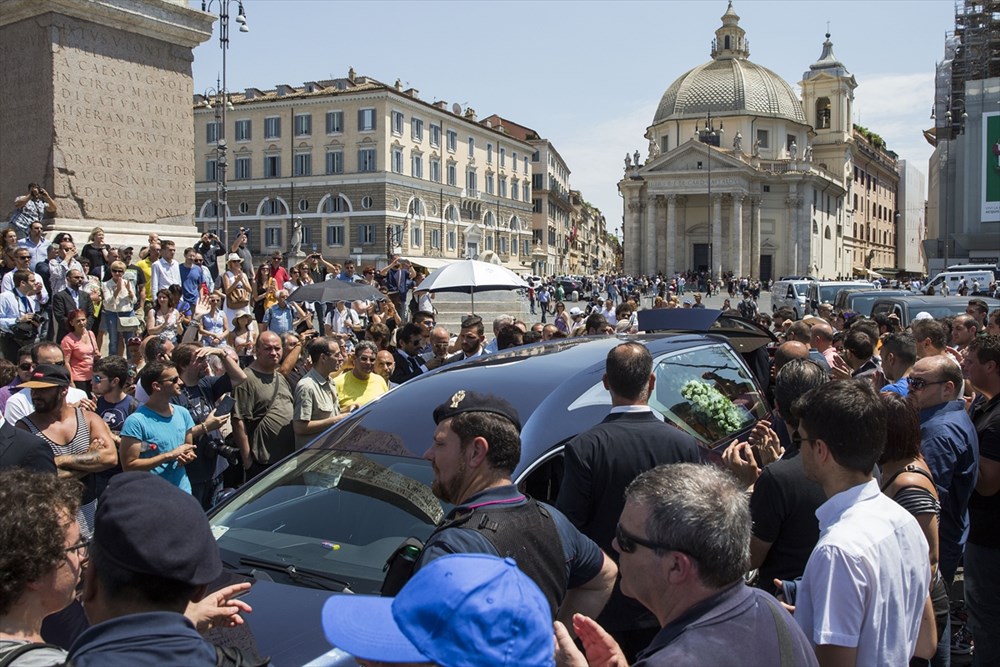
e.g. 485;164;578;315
878;392;951;658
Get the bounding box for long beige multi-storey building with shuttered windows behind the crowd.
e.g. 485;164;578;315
194;69;533;272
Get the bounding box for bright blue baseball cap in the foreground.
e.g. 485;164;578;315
323;554;555;667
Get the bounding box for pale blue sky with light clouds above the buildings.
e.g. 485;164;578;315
190;0;955;235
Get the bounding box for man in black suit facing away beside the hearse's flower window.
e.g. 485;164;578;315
556;343;701;660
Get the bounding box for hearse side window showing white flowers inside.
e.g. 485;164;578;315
649;345;767;445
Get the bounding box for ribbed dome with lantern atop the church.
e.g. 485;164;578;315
653;2;806;125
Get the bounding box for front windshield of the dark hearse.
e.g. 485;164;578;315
211;448;448;594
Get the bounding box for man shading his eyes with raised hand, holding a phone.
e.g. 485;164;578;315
171;343;247;510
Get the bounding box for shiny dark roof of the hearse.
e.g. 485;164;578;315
310;334;740;476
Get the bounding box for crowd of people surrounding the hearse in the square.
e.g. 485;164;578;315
0;217;1000;666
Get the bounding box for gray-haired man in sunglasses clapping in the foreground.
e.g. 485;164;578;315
556;463;817;667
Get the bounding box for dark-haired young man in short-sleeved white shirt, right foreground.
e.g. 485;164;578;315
788;380;933;666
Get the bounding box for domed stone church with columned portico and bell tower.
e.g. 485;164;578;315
618;2;862;280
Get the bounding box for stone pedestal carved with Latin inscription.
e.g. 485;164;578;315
0;0;214;247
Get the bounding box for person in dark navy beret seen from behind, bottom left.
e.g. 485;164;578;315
69;472;249;667
